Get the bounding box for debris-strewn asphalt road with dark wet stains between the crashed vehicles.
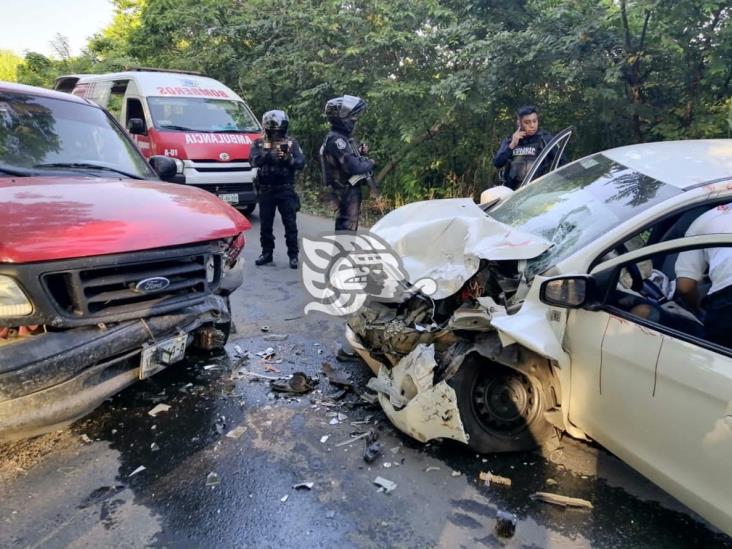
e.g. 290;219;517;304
0;208;732;548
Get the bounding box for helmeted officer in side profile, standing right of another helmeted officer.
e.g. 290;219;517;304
320;95;376;231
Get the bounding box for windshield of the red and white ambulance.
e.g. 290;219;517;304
147;97;259;133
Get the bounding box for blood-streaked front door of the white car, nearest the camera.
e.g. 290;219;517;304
565;234;732;532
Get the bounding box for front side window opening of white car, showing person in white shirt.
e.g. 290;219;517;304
606;244;732;350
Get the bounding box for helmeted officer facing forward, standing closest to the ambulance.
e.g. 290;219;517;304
251;111;305;269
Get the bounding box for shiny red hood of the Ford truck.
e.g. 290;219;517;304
0;177;251;263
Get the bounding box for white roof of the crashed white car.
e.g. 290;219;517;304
602;139;732;190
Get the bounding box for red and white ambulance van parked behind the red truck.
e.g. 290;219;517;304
54;68;261;213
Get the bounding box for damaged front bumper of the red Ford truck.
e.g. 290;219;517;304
0;295;230;440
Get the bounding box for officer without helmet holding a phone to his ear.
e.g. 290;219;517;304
493;105;553;190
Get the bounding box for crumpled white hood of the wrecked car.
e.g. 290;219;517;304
371;198;551;299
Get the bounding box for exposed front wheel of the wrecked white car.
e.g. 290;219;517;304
449;357;554;454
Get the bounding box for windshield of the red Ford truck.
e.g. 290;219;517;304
0;91;155;179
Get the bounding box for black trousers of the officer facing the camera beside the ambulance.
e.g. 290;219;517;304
259;185;300;257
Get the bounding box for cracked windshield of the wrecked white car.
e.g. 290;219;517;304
489;154;681;278
